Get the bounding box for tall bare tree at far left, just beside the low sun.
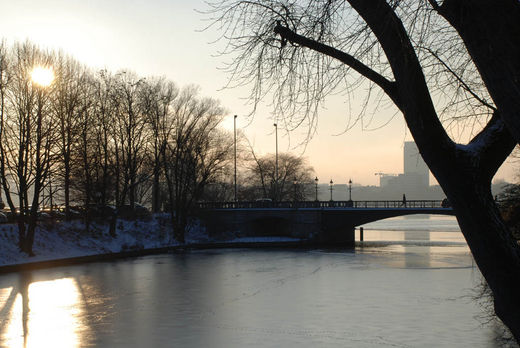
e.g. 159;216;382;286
1;42;56;255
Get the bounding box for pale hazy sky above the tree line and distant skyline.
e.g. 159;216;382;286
0;0;515;185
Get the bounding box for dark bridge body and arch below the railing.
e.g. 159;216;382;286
200;208;454;245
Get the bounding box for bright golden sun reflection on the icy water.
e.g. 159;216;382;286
0;278;84;347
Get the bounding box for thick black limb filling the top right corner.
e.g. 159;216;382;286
435;0;520;144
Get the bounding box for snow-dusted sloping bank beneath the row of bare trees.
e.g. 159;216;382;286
0;214;300;267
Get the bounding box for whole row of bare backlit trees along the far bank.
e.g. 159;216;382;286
0;42;312;254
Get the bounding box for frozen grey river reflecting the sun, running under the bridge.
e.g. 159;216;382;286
0;217;512;348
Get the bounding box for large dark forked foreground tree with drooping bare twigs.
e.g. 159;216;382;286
206;0;520;341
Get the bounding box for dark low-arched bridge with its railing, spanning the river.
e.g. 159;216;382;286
198;200;454;245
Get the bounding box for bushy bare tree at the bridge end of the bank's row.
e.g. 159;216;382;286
162;87;233;242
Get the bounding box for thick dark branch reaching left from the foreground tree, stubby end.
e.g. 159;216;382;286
274;22;400;108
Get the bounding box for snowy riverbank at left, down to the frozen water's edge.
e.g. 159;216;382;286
0;214;307;273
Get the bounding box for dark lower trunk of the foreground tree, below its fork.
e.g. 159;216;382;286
442;172;520;342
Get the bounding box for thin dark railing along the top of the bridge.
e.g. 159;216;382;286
197;200;443;209
